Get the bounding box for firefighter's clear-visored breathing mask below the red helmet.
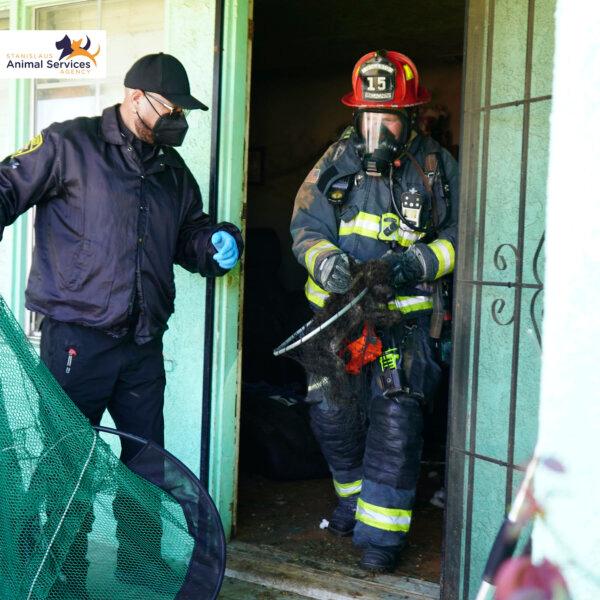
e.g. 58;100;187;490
356;110;410;176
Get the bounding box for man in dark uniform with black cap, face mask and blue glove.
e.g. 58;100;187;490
0;53;243;597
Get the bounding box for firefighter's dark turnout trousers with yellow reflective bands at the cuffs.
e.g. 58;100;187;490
307;318;441;547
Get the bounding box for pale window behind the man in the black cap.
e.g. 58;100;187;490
25;0;165;337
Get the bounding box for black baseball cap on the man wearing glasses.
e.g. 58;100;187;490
125;52;208;110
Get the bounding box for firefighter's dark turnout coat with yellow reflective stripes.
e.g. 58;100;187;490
290;133;459;316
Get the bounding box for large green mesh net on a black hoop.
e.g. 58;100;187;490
0;298;225;600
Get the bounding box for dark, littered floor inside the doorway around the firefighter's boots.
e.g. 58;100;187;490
235;464;443;582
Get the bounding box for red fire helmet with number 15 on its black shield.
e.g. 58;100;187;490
342;50;431;108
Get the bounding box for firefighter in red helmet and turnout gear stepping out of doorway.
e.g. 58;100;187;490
290;51;458;571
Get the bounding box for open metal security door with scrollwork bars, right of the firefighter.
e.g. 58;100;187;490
443;0;555;600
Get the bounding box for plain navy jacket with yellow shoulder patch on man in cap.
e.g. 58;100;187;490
0;105;243;343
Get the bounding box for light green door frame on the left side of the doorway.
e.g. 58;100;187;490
206;0;253;538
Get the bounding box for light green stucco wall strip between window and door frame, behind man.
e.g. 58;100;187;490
164;0;215;490
